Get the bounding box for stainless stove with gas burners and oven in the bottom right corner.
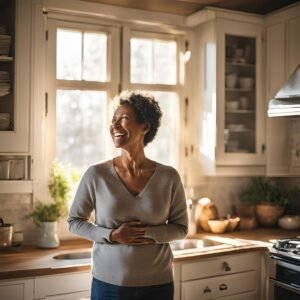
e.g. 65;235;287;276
269;236;300;300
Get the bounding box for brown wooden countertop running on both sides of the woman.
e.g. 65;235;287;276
0;228;300;279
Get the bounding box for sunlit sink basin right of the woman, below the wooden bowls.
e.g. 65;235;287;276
170;239;224;251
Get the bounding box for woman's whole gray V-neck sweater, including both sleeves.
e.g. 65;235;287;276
68;160;188;286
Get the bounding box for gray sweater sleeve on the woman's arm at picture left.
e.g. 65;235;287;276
68;169;112;243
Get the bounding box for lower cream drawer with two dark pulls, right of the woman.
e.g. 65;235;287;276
181;271;257;300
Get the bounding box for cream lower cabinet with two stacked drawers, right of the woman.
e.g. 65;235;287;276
180;252;266;300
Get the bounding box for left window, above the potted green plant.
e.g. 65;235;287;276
48;20;119;171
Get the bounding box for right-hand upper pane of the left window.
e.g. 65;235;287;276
83;33;107;81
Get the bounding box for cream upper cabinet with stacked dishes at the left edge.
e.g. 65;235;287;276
0;0;31;153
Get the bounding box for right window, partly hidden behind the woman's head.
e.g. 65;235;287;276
123;30;183;167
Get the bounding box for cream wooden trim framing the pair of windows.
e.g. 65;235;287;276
32;7;187;201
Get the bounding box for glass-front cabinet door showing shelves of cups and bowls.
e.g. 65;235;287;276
216;20;265;165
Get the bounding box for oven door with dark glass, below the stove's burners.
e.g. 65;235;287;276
269;256;300;300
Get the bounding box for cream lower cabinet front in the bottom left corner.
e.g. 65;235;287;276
0;278;34;300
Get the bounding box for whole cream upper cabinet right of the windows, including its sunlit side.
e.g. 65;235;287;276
189;12;266;180
